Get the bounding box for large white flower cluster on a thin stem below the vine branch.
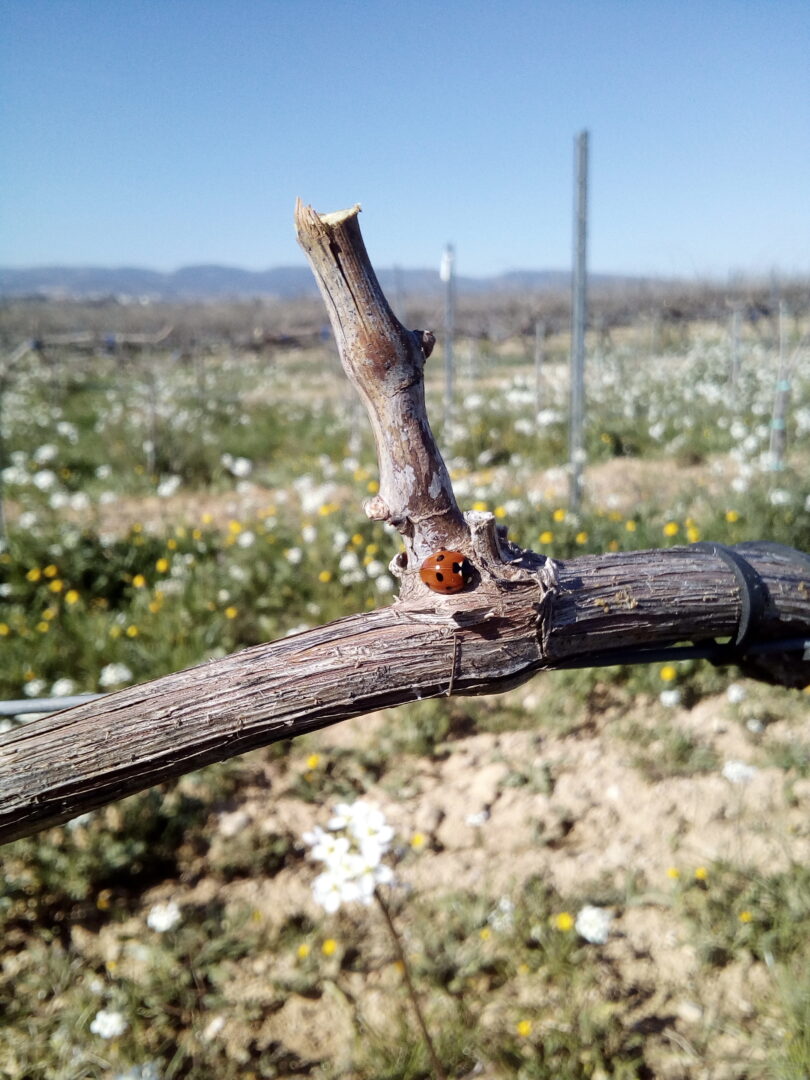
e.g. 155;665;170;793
303;799;394;914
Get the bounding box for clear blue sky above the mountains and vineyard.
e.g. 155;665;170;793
0;0;810;278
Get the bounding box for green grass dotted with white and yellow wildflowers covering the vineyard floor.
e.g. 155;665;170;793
0;330;810;1080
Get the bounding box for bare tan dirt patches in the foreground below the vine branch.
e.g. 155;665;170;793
117;679;810;1080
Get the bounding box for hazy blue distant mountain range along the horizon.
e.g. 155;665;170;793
0;266;644;301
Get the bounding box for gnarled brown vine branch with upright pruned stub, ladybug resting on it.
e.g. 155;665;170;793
0;203;810;842
